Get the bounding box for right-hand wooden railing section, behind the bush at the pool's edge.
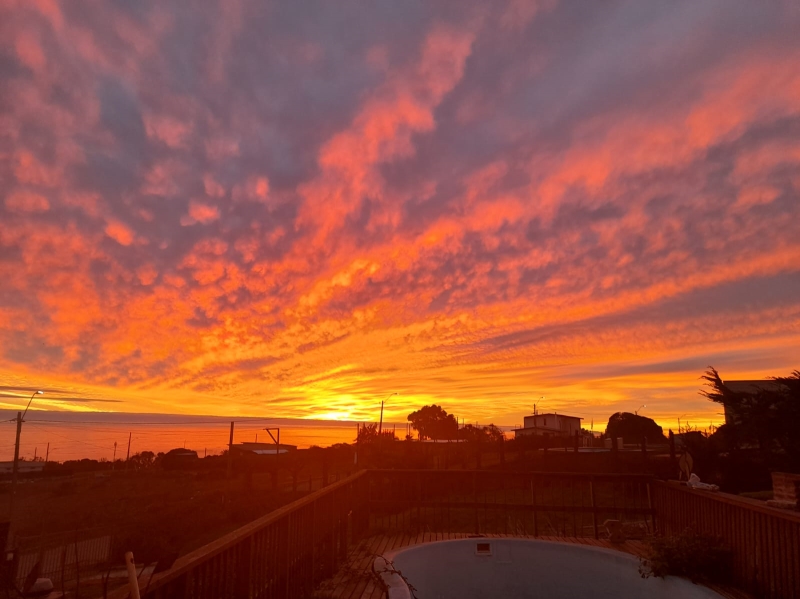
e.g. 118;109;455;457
653;482;800;599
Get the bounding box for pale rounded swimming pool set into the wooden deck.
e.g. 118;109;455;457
373;538;721;599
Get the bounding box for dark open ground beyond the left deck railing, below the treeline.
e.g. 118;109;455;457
0;450;354;562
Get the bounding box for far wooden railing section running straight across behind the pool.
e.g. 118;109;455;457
368;470;655;538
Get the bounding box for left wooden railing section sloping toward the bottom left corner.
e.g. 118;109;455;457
110;471;368;599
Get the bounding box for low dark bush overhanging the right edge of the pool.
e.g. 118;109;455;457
639;528;733;583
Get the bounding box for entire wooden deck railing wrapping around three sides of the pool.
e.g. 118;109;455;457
111;470;800;599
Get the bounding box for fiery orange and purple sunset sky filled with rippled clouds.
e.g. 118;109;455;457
0;0;800;430
